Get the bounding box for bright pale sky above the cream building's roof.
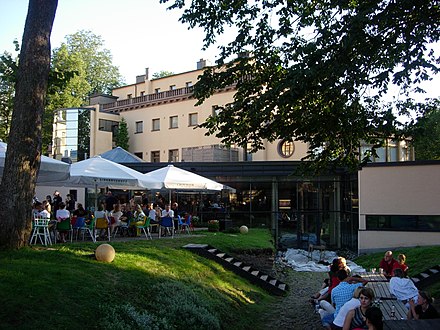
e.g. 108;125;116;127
0;0;217;84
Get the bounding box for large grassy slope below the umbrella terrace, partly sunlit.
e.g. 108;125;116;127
0;229;274;329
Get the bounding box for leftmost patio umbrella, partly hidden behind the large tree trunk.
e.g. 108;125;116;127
0;142;70;186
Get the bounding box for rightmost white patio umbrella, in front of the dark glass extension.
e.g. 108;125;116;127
144;165;228;191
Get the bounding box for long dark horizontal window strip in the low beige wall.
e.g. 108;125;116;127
366;215;440;231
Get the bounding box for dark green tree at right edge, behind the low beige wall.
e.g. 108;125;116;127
408;99;440;160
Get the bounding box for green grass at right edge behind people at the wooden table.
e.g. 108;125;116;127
354;246;440;299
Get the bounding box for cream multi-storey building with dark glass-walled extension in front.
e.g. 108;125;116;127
48;60;440;250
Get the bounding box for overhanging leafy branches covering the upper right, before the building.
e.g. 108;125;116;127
161;0;440;171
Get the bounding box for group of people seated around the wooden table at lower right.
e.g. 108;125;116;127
310;251;439;330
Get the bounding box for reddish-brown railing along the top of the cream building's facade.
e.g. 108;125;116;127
102;86;194;111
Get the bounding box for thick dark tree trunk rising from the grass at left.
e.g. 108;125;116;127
0;0;58;249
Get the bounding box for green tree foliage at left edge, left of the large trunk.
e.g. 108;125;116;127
0;41;19;142
